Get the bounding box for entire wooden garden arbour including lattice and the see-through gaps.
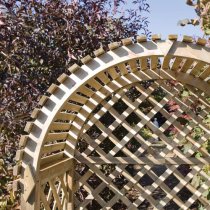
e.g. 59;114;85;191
14;35;210;210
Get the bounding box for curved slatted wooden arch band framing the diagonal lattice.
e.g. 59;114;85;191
14;35;210;209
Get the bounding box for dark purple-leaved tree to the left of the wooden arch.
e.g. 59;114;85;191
0;0;150;208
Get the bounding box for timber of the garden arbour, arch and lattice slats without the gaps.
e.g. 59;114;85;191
14;35;210;209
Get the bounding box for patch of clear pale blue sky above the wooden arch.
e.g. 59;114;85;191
148;0;203;39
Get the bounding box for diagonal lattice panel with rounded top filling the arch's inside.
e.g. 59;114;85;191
75;80;209;209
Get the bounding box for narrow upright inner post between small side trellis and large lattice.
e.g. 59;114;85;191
67;159;76;210
